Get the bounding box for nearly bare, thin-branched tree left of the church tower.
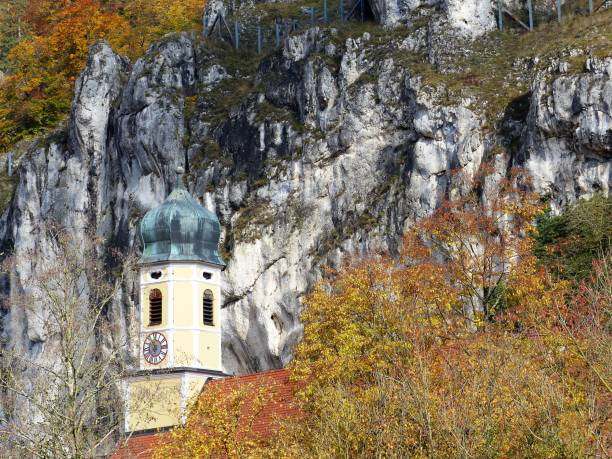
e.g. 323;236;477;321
0;230;135;458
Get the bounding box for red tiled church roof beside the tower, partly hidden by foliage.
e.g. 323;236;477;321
111;369;299;459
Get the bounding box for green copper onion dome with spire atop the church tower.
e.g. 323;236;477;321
140;168;225;266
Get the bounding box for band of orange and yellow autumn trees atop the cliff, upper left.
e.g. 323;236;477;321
0;0;205;151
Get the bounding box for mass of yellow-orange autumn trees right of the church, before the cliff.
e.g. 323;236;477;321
270;182;610;458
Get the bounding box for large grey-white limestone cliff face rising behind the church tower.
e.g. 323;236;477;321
0;17;612;380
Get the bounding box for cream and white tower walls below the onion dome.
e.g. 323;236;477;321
124;262;223;432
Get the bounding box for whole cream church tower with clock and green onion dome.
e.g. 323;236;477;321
125;169;225;432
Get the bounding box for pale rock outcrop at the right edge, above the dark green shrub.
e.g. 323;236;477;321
520;58;612;210
